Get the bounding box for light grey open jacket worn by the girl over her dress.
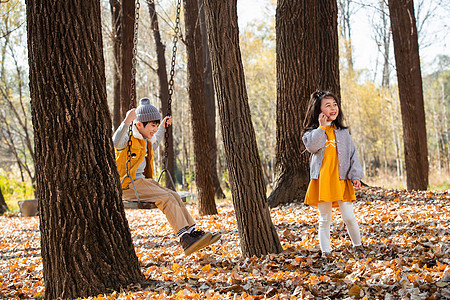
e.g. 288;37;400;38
302;127;363;180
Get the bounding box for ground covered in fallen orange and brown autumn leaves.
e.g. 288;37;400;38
0;188;450;299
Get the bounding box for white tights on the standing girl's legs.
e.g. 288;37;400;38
317;201;361;252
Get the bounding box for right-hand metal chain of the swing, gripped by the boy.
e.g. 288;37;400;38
163;0;181;169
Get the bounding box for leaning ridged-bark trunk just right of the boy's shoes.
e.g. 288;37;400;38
204;0;282;257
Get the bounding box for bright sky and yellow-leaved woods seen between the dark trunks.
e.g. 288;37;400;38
0;0;450;210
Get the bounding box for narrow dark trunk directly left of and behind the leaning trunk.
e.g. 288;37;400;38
184;0;217;216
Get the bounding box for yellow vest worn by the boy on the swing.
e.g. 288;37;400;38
115;136;153;189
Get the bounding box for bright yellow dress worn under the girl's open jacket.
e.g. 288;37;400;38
305;125;356;207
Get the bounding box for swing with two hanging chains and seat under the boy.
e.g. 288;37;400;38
120;0;185;209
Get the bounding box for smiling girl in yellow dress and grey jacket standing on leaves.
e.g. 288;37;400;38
302;91;363;258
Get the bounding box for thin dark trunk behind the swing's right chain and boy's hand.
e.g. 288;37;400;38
147;0;175;189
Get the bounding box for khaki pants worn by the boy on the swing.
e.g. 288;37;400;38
122;178;195;233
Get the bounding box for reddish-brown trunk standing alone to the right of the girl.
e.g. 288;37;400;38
389;0;428;190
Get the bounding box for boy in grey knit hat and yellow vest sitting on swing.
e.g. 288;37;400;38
113;98;221;255
